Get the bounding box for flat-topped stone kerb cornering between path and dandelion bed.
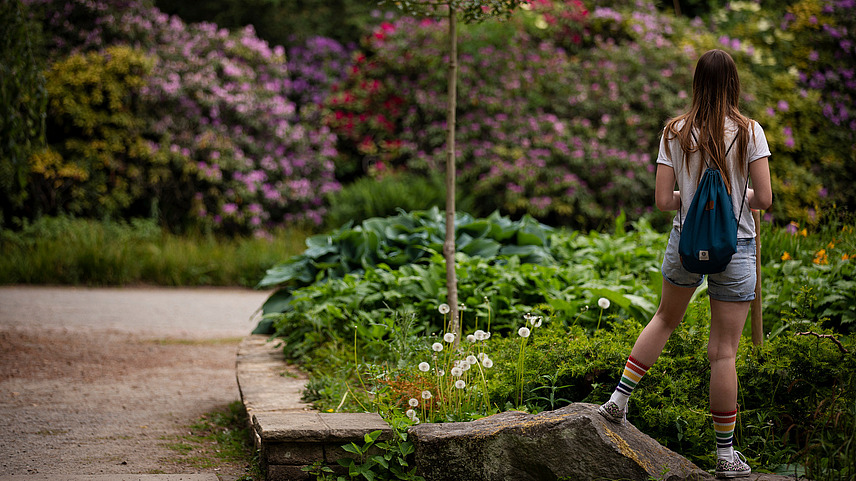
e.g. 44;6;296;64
236;335;392;481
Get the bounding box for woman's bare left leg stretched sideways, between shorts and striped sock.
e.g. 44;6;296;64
630;280;695;366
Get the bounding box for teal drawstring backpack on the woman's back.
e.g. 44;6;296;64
678;133;749;274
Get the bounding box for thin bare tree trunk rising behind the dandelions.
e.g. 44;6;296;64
443;5;461;346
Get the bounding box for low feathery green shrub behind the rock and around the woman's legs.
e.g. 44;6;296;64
474;314;856;479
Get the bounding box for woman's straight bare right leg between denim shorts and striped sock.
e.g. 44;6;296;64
707;299;749;412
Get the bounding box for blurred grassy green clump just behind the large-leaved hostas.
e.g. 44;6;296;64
324;174;454;227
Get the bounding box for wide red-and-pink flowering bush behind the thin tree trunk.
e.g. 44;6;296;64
325;7;691;228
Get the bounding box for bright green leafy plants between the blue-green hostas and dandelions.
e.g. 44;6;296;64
262;212;664;359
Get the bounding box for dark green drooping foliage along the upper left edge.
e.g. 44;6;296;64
0;0;47;221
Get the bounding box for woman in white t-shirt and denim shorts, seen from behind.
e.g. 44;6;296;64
599;50;773;478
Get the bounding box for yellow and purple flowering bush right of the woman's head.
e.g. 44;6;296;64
710;0;856;224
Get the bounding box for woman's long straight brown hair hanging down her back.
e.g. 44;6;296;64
664;50;752;193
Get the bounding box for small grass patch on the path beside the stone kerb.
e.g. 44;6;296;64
165;401;262;481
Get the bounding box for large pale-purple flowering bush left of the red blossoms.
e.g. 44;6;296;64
22;0;339;233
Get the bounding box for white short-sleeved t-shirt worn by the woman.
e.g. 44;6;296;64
657;119;771;239
